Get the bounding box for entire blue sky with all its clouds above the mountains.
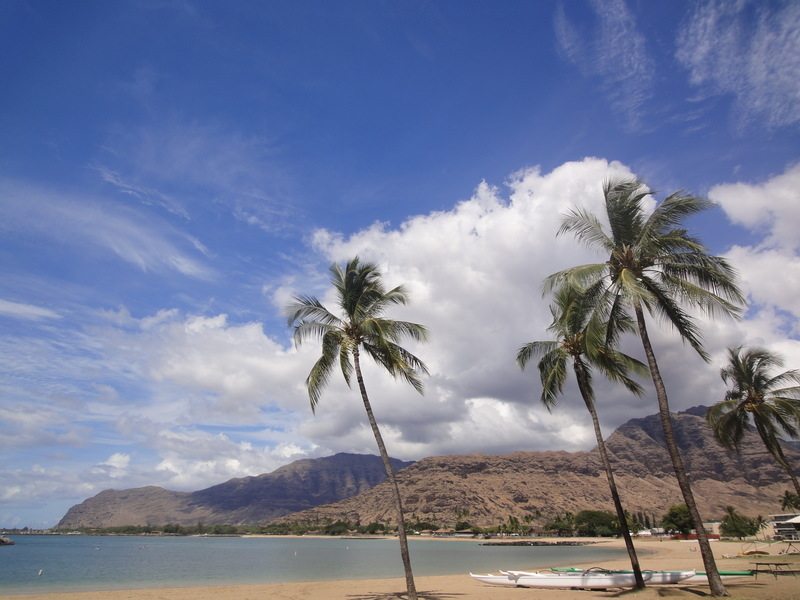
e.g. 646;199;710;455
0;0;800;526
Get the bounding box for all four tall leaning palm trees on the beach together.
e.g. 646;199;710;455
286;179;800;600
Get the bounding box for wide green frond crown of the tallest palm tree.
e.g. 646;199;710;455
543;178;745;378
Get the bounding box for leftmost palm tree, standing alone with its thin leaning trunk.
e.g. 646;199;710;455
286;257;428;600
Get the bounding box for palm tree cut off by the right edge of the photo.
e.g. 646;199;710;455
706;346;800;496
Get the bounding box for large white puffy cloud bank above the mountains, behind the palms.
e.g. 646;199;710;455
6;158;800;524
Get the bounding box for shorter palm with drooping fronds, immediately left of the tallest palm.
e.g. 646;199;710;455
517;286;647;589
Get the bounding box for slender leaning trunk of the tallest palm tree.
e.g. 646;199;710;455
634;303;728;596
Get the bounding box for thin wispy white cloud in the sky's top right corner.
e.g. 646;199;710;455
676;0;800;129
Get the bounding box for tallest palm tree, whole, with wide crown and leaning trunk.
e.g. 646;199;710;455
545;179;744;596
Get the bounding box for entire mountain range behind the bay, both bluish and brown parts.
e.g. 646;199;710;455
58;408;800;528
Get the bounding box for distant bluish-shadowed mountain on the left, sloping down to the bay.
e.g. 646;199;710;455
56;454;411;529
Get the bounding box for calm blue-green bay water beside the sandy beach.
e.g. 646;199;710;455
0;535;625;594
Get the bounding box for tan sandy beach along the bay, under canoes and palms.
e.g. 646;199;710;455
0;539;800;600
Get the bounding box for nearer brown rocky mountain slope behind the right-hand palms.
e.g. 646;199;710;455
278;410;800;527
